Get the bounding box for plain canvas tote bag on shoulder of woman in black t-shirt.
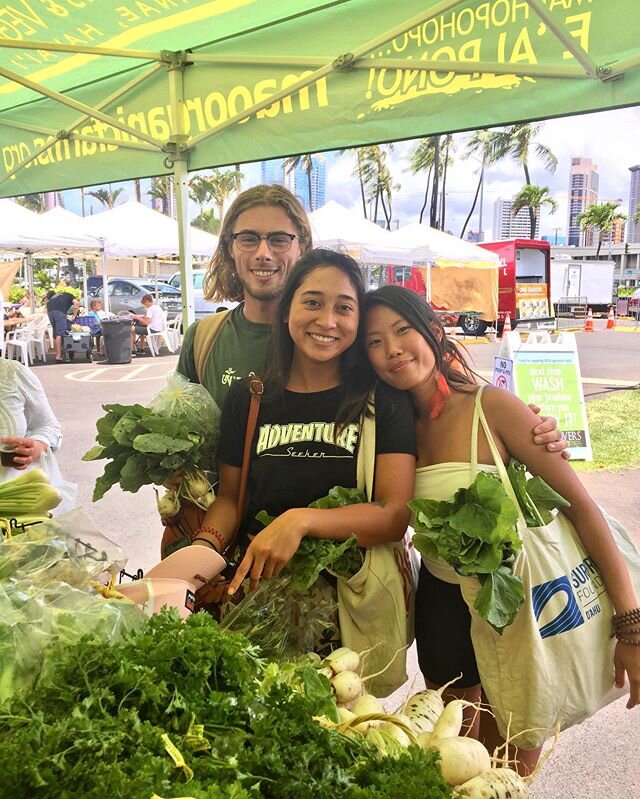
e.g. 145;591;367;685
338;404;414;696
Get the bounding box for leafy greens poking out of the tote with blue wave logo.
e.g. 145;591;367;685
409;460;568;633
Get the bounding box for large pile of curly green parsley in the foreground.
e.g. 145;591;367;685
0;611;451;799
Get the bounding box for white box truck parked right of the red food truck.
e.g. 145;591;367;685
551;258;615;315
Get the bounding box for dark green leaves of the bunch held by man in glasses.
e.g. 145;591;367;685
82;403;218;502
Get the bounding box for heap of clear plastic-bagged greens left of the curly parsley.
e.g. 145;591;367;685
0;510;144;702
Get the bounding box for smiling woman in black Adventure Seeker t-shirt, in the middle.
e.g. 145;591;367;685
194;249;415;593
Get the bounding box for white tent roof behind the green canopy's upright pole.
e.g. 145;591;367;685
80;200;218;258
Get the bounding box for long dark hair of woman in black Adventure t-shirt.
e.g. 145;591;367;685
265;247;375;429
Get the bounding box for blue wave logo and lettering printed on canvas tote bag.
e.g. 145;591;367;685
531;557;604;638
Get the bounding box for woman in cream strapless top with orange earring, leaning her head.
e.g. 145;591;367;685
365;286;640;772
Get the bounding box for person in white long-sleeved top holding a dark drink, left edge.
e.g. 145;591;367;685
0;358;75;514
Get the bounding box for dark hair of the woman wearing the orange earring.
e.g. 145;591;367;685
363;286;478;391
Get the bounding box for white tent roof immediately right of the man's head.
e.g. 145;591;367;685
309;200;424;265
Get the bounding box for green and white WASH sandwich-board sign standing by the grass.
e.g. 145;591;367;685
493;331;592;461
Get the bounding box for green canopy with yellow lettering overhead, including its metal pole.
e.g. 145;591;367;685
0;0;640;320
